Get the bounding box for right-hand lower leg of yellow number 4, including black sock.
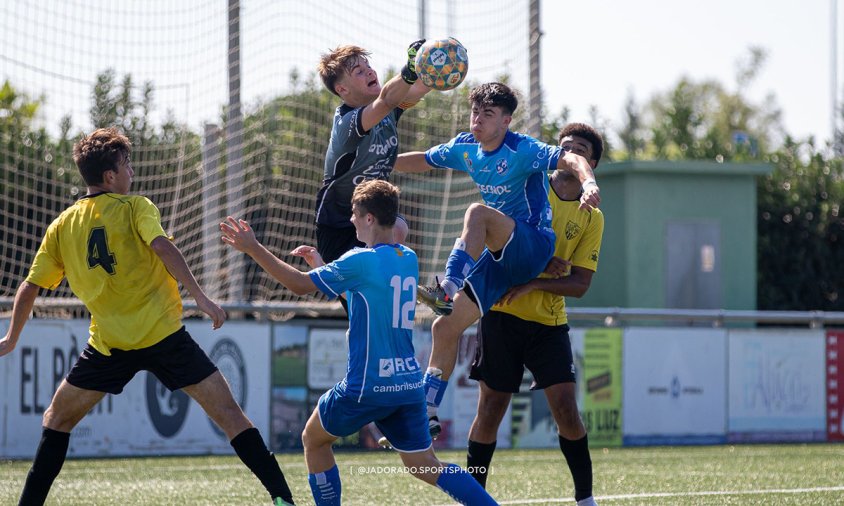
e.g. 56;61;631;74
182;371;293;504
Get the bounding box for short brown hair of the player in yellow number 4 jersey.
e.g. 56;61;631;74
73;127;132;186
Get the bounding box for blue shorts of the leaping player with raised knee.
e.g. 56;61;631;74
464;221;556;316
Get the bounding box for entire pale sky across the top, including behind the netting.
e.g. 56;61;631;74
0;0;844;146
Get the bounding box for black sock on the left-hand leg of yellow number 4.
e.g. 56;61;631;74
18;427;70;506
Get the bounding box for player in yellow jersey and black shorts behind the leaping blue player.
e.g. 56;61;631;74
466;123;604;506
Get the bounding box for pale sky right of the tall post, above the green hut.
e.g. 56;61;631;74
541;0;844;140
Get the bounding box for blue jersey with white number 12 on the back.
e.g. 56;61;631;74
309;244;425;406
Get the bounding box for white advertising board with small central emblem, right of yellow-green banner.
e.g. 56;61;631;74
622;328;727;445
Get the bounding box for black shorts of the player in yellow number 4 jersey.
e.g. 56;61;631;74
67;327;217;394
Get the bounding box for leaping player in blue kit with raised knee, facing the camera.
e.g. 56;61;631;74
395;83;600;436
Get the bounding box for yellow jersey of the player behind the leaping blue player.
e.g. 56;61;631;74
492;184;604;325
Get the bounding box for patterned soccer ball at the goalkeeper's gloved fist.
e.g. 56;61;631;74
416;37;469;91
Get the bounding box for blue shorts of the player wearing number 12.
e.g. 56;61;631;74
317;388;431;453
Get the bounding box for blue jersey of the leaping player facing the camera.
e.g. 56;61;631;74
425;131;562;231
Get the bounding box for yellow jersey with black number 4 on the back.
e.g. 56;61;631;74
26;193;182;355
